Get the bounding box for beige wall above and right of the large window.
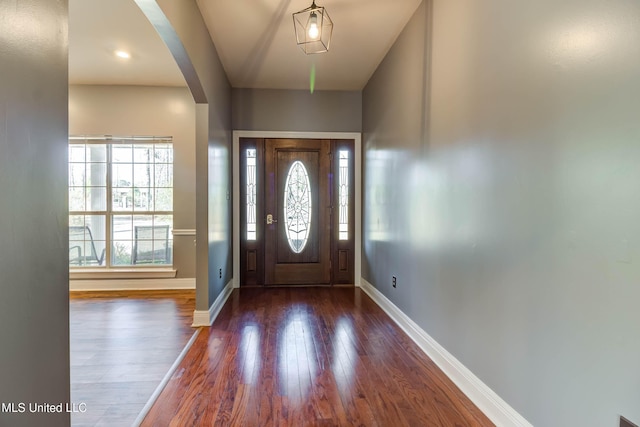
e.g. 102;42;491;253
69;85;196;277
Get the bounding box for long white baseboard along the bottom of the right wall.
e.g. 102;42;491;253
360;278;532;427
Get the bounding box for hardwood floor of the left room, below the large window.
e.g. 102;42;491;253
69;291;195;427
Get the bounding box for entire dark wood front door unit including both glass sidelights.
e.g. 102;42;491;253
238;138;355;286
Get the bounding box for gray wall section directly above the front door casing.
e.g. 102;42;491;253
231;89;362;132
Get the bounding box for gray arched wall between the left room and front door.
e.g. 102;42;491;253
152;0;233;310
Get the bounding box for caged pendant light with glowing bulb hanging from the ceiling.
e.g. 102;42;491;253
293;0;333;55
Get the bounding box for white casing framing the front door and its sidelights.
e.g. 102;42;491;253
232;130;362;288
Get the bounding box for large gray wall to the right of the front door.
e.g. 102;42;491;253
363;0;640;427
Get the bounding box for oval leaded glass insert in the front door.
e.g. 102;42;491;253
284;160;311;254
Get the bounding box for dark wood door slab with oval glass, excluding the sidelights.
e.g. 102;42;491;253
264;139;331;285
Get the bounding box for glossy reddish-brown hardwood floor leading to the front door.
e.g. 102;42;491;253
142;288;493;427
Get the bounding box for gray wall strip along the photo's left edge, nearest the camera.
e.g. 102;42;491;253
0;0;69;426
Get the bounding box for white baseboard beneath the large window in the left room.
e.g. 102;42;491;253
69;278;196;291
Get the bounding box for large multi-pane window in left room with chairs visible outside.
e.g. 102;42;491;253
69;137;173;267
